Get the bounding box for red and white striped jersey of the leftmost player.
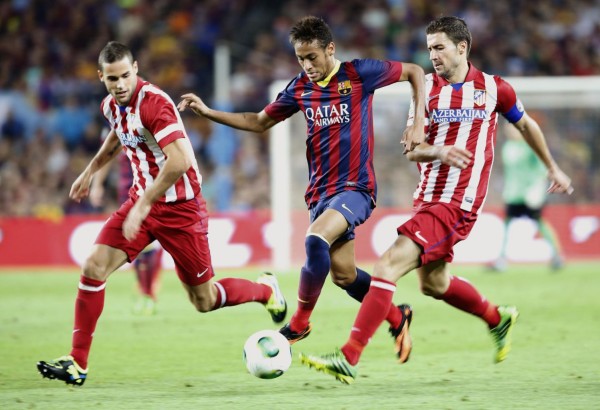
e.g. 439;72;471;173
100;79;202;202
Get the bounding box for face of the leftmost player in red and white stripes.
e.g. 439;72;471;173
98;57;138;105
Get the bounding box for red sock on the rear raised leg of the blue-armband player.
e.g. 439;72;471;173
439;276;500;328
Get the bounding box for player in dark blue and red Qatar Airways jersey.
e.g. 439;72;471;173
178;16;425;362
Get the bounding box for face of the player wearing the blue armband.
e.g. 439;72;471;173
427;33;467;83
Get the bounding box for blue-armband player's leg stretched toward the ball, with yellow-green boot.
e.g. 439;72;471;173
300;235;421;383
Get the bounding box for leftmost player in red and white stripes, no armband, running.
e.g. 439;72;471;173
37;41;287;386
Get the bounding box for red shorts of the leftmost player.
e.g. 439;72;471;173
96;195;214;286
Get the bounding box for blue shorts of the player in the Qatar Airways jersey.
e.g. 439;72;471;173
310;191;375;241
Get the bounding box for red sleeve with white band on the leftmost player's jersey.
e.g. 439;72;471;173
140;94;185;149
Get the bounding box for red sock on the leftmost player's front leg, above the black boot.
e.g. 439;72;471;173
71;275;106;369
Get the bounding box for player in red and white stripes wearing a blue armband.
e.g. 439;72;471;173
301;17;572;383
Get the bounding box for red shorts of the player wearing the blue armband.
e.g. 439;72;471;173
397;202;477;266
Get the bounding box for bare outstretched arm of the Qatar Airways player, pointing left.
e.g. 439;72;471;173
177;93;277;133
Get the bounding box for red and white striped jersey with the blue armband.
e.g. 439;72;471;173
408;64;524;213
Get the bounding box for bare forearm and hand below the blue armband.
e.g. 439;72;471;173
514;113;573;195
